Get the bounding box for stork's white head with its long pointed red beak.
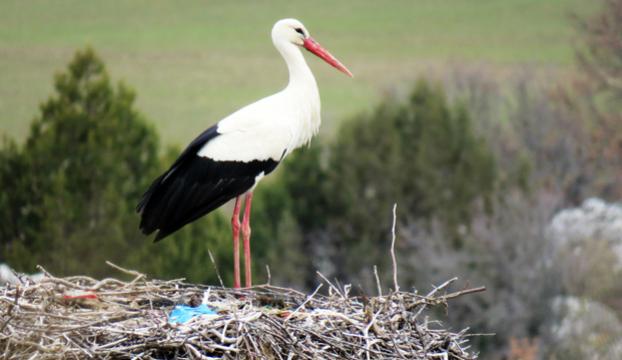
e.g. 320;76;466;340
272;19;352;77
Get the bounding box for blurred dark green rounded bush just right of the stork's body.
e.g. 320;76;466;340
282;81;496;288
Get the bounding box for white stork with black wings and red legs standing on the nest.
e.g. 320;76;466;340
137;19;352;288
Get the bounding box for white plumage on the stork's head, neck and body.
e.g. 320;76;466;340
198;19;321;161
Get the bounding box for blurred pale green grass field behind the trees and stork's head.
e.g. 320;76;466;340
0;0;595;144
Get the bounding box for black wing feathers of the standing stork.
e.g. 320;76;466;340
136;126;278;241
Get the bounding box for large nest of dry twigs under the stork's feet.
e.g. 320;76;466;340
0;262;483;359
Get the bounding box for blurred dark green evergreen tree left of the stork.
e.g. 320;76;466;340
0;49;159;275
